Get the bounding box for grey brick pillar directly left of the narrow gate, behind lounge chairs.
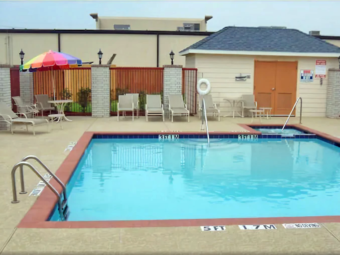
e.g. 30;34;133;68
163;65;182;115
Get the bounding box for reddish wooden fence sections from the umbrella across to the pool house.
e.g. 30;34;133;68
33;67;197;115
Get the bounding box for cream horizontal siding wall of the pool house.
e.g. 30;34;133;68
193;54;338;117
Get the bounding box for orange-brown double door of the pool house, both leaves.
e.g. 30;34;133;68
254;61;297;115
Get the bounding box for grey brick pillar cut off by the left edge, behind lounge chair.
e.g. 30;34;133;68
0;65;12;130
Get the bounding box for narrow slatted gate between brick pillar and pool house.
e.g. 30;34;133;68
182;68;197;115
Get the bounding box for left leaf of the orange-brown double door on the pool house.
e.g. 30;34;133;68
254;61;276;108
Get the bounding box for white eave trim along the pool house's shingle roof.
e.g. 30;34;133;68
179;49;340;58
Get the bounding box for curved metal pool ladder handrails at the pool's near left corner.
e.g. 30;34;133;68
11;155;70;221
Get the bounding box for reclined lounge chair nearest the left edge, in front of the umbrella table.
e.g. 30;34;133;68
0;102;49;135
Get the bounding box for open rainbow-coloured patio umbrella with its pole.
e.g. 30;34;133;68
20;50;82;100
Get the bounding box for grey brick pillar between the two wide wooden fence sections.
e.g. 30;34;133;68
91;65;110;118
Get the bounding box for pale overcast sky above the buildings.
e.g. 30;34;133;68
0;1;340;35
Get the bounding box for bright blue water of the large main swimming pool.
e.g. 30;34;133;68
51;138;340;221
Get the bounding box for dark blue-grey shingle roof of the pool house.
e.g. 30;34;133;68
181;27;340;54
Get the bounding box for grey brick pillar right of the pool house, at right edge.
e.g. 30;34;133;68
326;69;340;118
